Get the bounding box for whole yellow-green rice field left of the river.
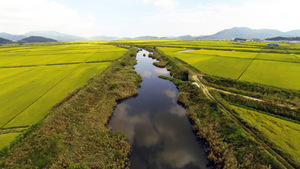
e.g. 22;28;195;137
0;43;127;148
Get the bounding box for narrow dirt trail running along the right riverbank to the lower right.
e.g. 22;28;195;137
192;75;294;168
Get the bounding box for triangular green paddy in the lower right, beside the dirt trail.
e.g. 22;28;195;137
232;106;300;163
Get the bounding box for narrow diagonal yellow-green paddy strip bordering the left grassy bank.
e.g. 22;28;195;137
4;63;110;128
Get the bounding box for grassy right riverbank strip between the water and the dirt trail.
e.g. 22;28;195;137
146;47;289;168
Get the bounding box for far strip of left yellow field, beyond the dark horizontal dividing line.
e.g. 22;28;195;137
0;44;127;67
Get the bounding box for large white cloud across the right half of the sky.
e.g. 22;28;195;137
142;0;300;36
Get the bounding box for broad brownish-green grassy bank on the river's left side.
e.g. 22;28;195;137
0;49;141;168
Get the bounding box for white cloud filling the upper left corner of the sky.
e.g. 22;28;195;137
0;0;94;35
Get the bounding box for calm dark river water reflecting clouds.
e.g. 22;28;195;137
109;50;208;169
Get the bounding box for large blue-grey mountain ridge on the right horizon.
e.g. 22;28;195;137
199;27;300;39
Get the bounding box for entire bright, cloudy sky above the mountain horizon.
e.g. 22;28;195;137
0;0;300;37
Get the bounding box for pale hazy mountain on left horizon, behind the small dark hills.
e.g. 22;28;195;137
24;31;87;41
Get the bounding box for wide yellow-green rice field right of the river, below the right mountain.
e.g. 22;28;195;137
157;41;300;90
